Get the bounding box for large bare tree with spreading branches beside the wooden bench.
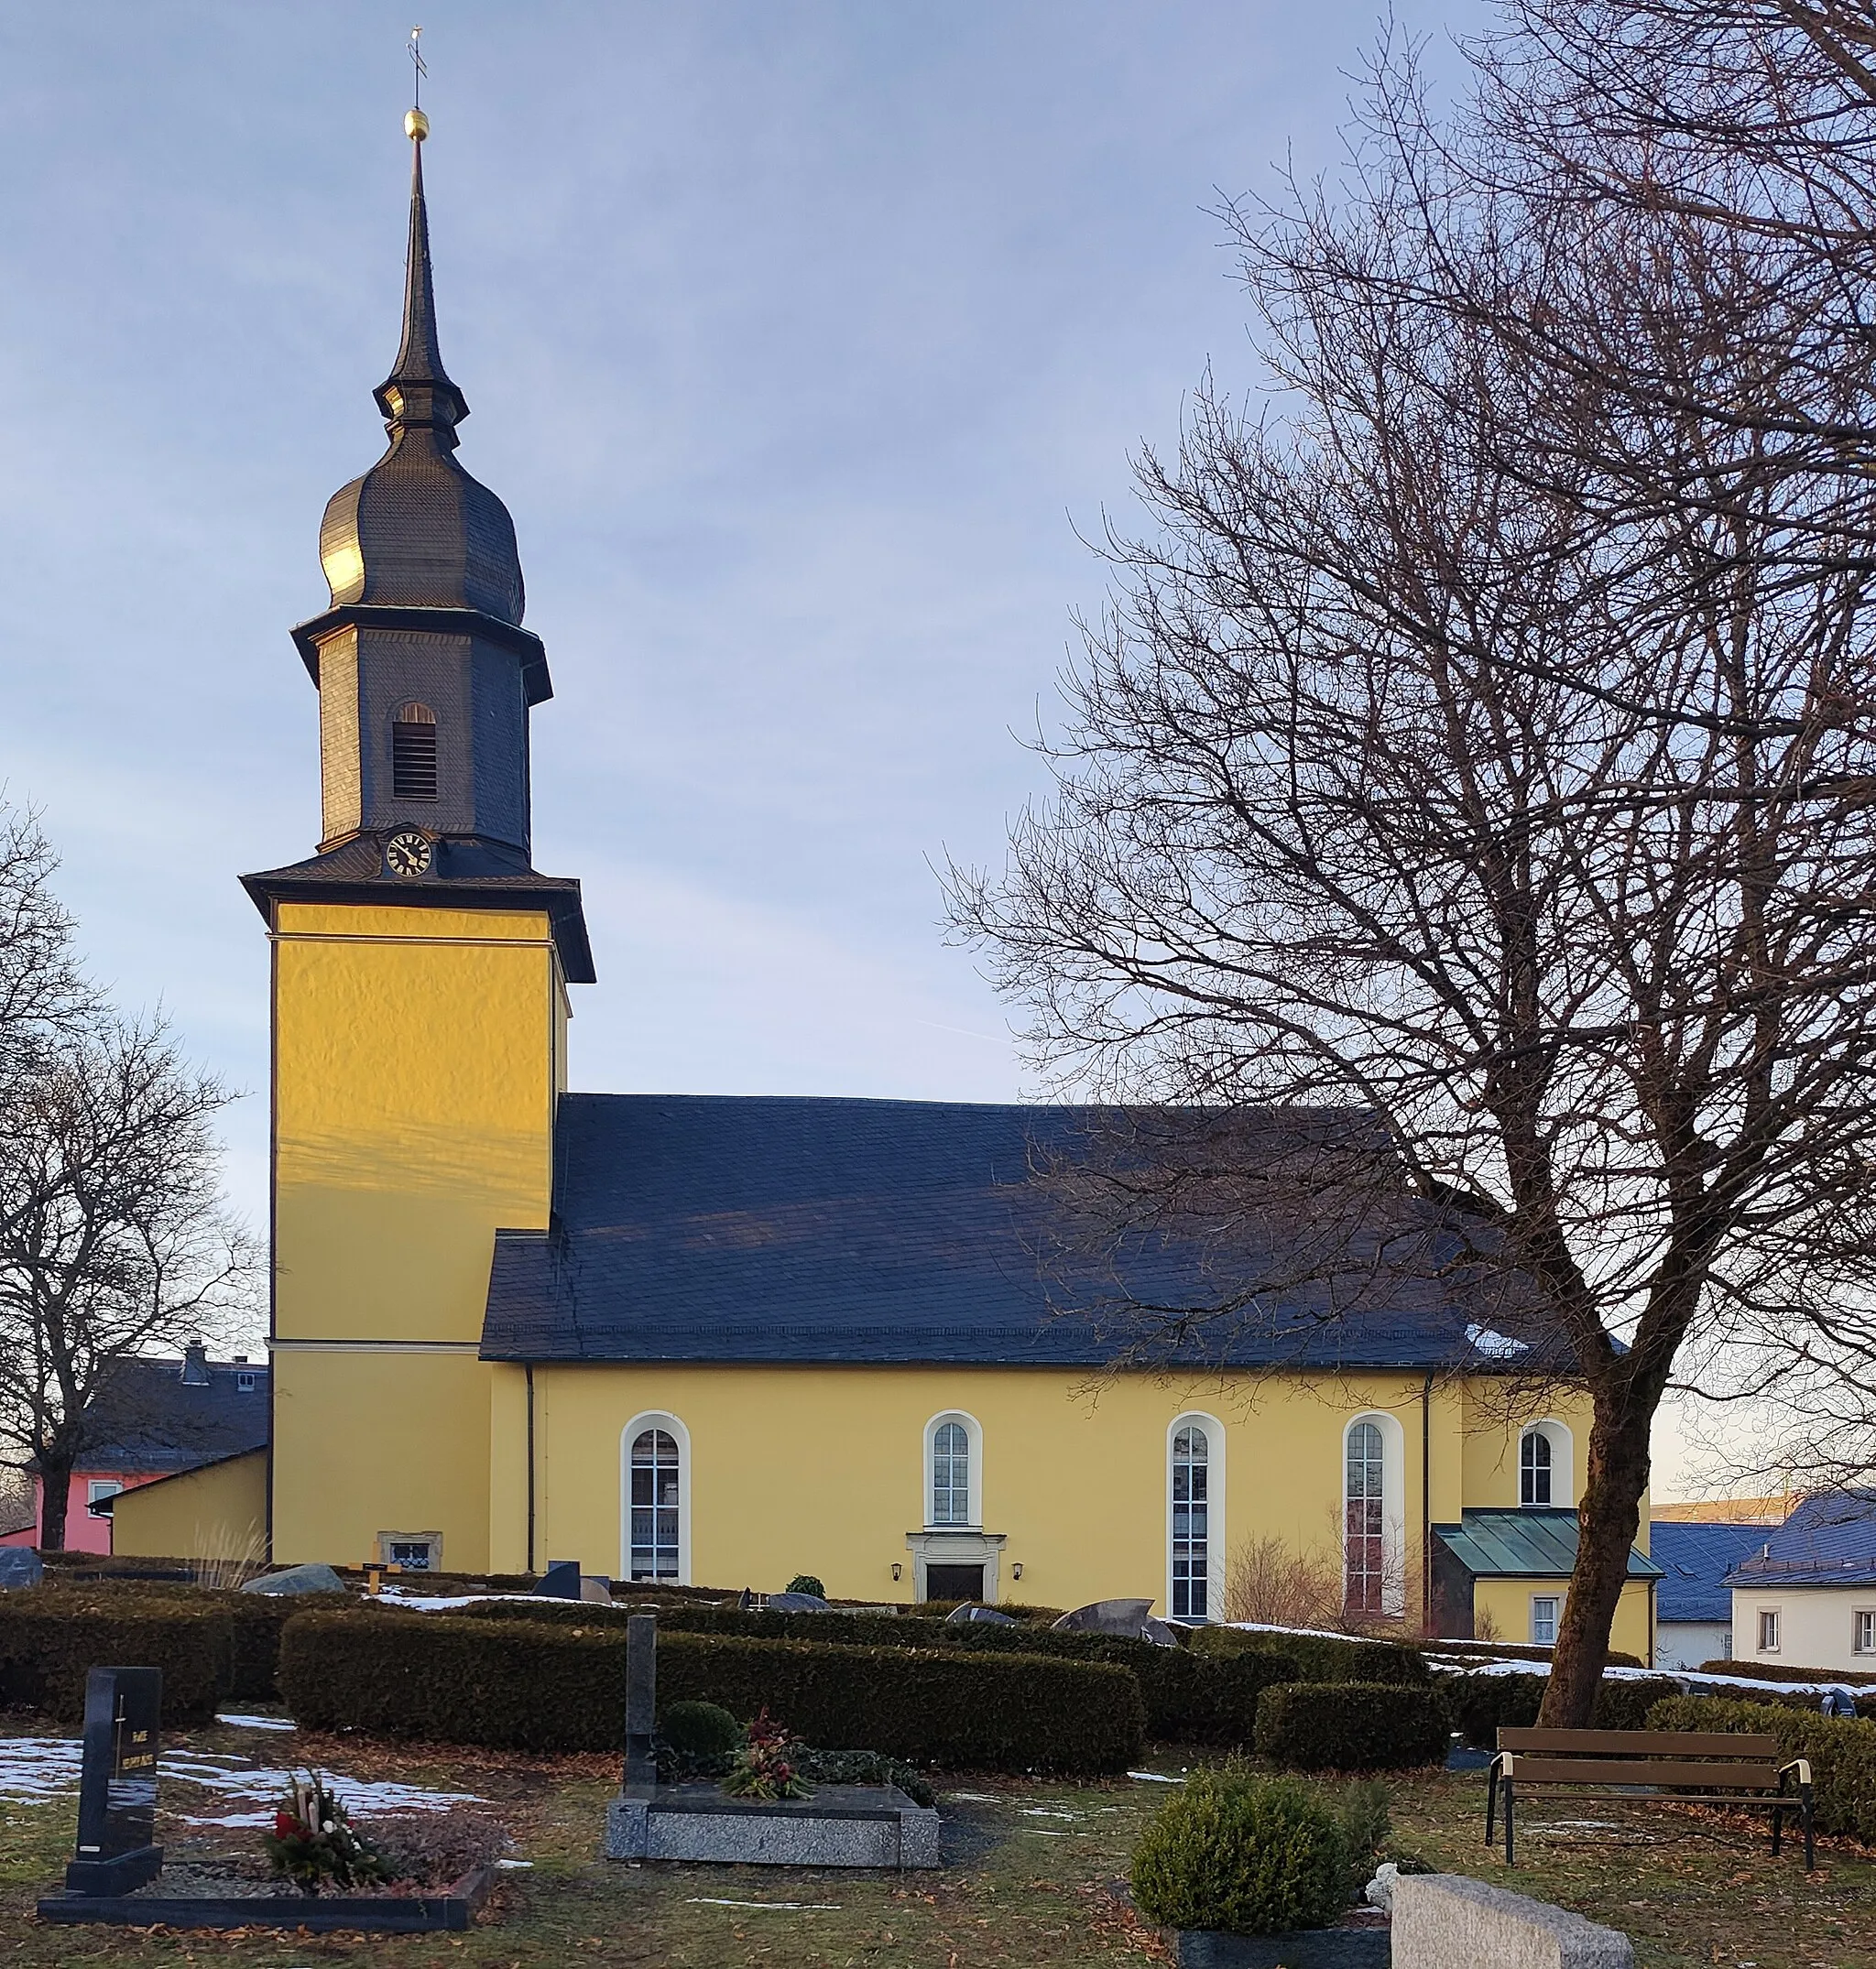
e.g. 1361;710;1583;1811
951;46;1876;1723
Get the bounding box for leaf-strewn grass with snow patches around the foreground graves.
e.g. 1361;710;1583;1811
0;1717;1876;1969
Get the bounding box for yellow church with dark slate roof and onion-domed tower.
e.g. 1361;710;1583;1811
116;110;1657;1659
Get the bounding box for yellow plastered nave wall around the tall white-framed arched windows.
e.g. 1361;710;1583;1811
536;1365;1461;1611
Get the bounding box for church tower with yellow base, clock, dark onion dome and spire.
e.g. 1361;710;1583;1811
242;110;593;1572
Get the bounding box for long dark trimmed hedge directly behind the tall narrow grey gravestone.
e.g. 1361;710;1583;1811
279;1609;1146;1772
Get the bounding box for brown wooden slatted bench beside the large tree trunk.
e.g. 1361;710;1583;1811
1484;1729;1817;1873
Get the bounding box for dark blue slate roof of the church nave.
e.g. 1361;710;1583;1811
483;1094;1551;1370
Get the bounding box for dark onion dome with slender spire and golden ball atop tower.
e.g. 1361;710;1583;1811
319;110;526;625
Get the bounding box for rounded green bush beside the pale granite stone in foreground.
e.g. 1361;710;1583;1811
1132;1770;1348;1935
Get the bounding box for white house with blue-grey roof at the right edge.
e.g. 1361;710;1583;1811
1727;1488;1876;1674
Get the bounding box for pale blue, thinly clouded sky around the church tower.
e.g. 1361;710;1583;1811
0;0;1724;1488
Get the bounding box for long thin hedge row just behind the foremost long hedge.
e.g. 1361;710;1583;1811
463;1601;1301;1745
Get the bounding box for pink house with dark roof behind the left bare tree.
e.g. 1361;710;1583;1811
0;1344;272;1551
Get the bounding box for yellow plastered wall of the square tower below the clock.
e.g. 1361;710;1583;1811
274;904;567;1570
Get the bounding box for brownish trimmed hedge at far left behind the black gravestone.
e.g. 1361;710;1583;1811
0;1585;234;1729
